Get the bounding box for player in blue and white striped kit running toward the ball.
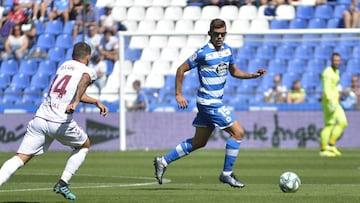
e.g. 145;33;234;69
154;19;266;188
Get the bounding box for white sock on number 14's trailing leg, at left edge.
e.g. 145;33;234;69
0;156;24;186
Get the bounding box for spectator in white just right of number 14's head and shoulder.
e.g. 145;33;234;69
89;55;107;92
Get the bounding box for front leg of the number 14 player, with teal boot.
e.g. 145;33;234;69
52;121;90;200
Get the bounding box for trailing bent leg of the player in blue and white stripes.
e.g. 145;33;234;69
154;127;213;184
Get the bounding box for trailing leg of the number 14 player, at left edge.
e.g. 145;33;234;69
0;118;52;186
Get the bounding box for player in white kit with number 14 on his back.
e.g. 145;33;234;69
0;42;108;200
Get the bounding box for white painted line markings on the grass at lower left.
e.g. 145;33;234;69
0;173;171;193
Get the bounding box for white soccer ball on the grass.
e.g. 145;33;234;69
279;171;301;193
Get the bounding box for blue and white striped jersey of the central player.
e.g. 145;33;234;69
187;41;234;106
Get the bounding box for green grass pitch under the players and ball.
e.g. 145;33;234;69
0;149;360;203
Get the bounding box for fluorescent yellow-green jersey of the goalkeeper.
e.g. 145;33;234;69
321;67;340;110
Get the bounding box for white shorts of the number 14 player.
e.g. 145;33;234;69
17;117;88;155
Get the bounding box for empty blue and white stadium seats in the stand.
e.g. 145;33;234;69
4;0;360;111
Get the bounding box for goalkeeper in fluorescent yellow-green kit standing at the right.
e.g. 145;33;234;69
320;53;348;157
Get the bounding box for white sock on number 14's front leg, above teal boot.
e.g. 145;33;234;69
61;148;89;184
